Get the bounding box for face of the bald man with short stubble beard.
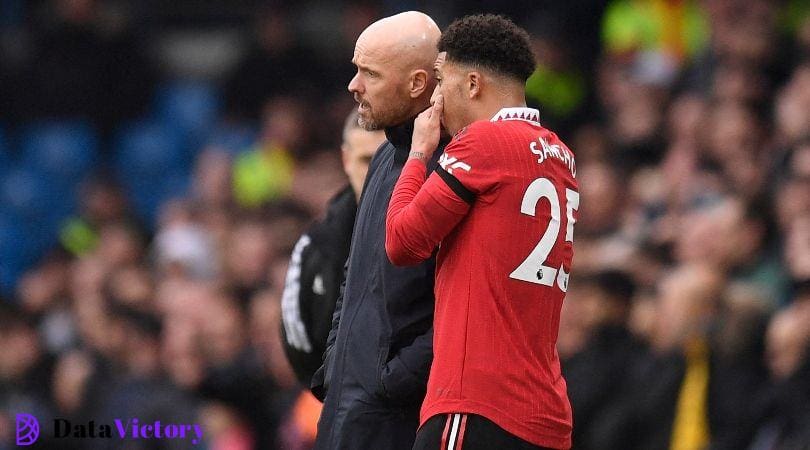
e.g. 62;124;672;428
349;36;411;131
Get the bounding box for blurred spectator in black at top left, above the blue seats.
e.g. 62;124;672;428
16;0;154;131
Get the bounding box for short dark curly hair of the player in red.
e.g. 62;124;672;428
439;14;537;83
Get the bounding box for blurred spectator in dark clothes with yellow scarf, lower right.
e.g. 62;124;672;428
593;264;761;450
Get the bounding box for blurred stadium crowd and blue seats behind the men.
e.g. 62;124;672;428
0;0;810;449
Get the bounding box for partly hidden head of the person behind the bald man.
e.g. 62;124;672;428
340;111;385;199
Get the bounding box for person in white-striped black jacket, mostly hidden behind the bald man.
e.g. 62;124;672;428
281;111;385;387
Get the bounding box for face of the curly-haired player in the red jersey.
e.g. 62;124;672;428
430;52;469;135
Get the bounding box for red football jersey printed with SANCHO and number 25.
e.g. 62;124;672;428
386;108;579;448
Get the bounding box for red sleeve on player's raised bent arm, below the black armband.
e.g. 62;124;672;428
385;159;470;266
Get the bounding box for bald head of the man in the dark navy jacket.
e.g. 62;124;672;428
349;11;441;131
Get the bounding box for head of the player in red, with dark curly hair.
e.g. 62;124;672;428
433;14;536;134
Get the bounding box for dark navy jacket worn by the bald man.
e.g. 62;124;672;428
312;120;443;450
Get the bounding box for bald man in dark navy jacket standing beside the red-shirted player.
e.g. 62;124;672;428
312;12;441;450
